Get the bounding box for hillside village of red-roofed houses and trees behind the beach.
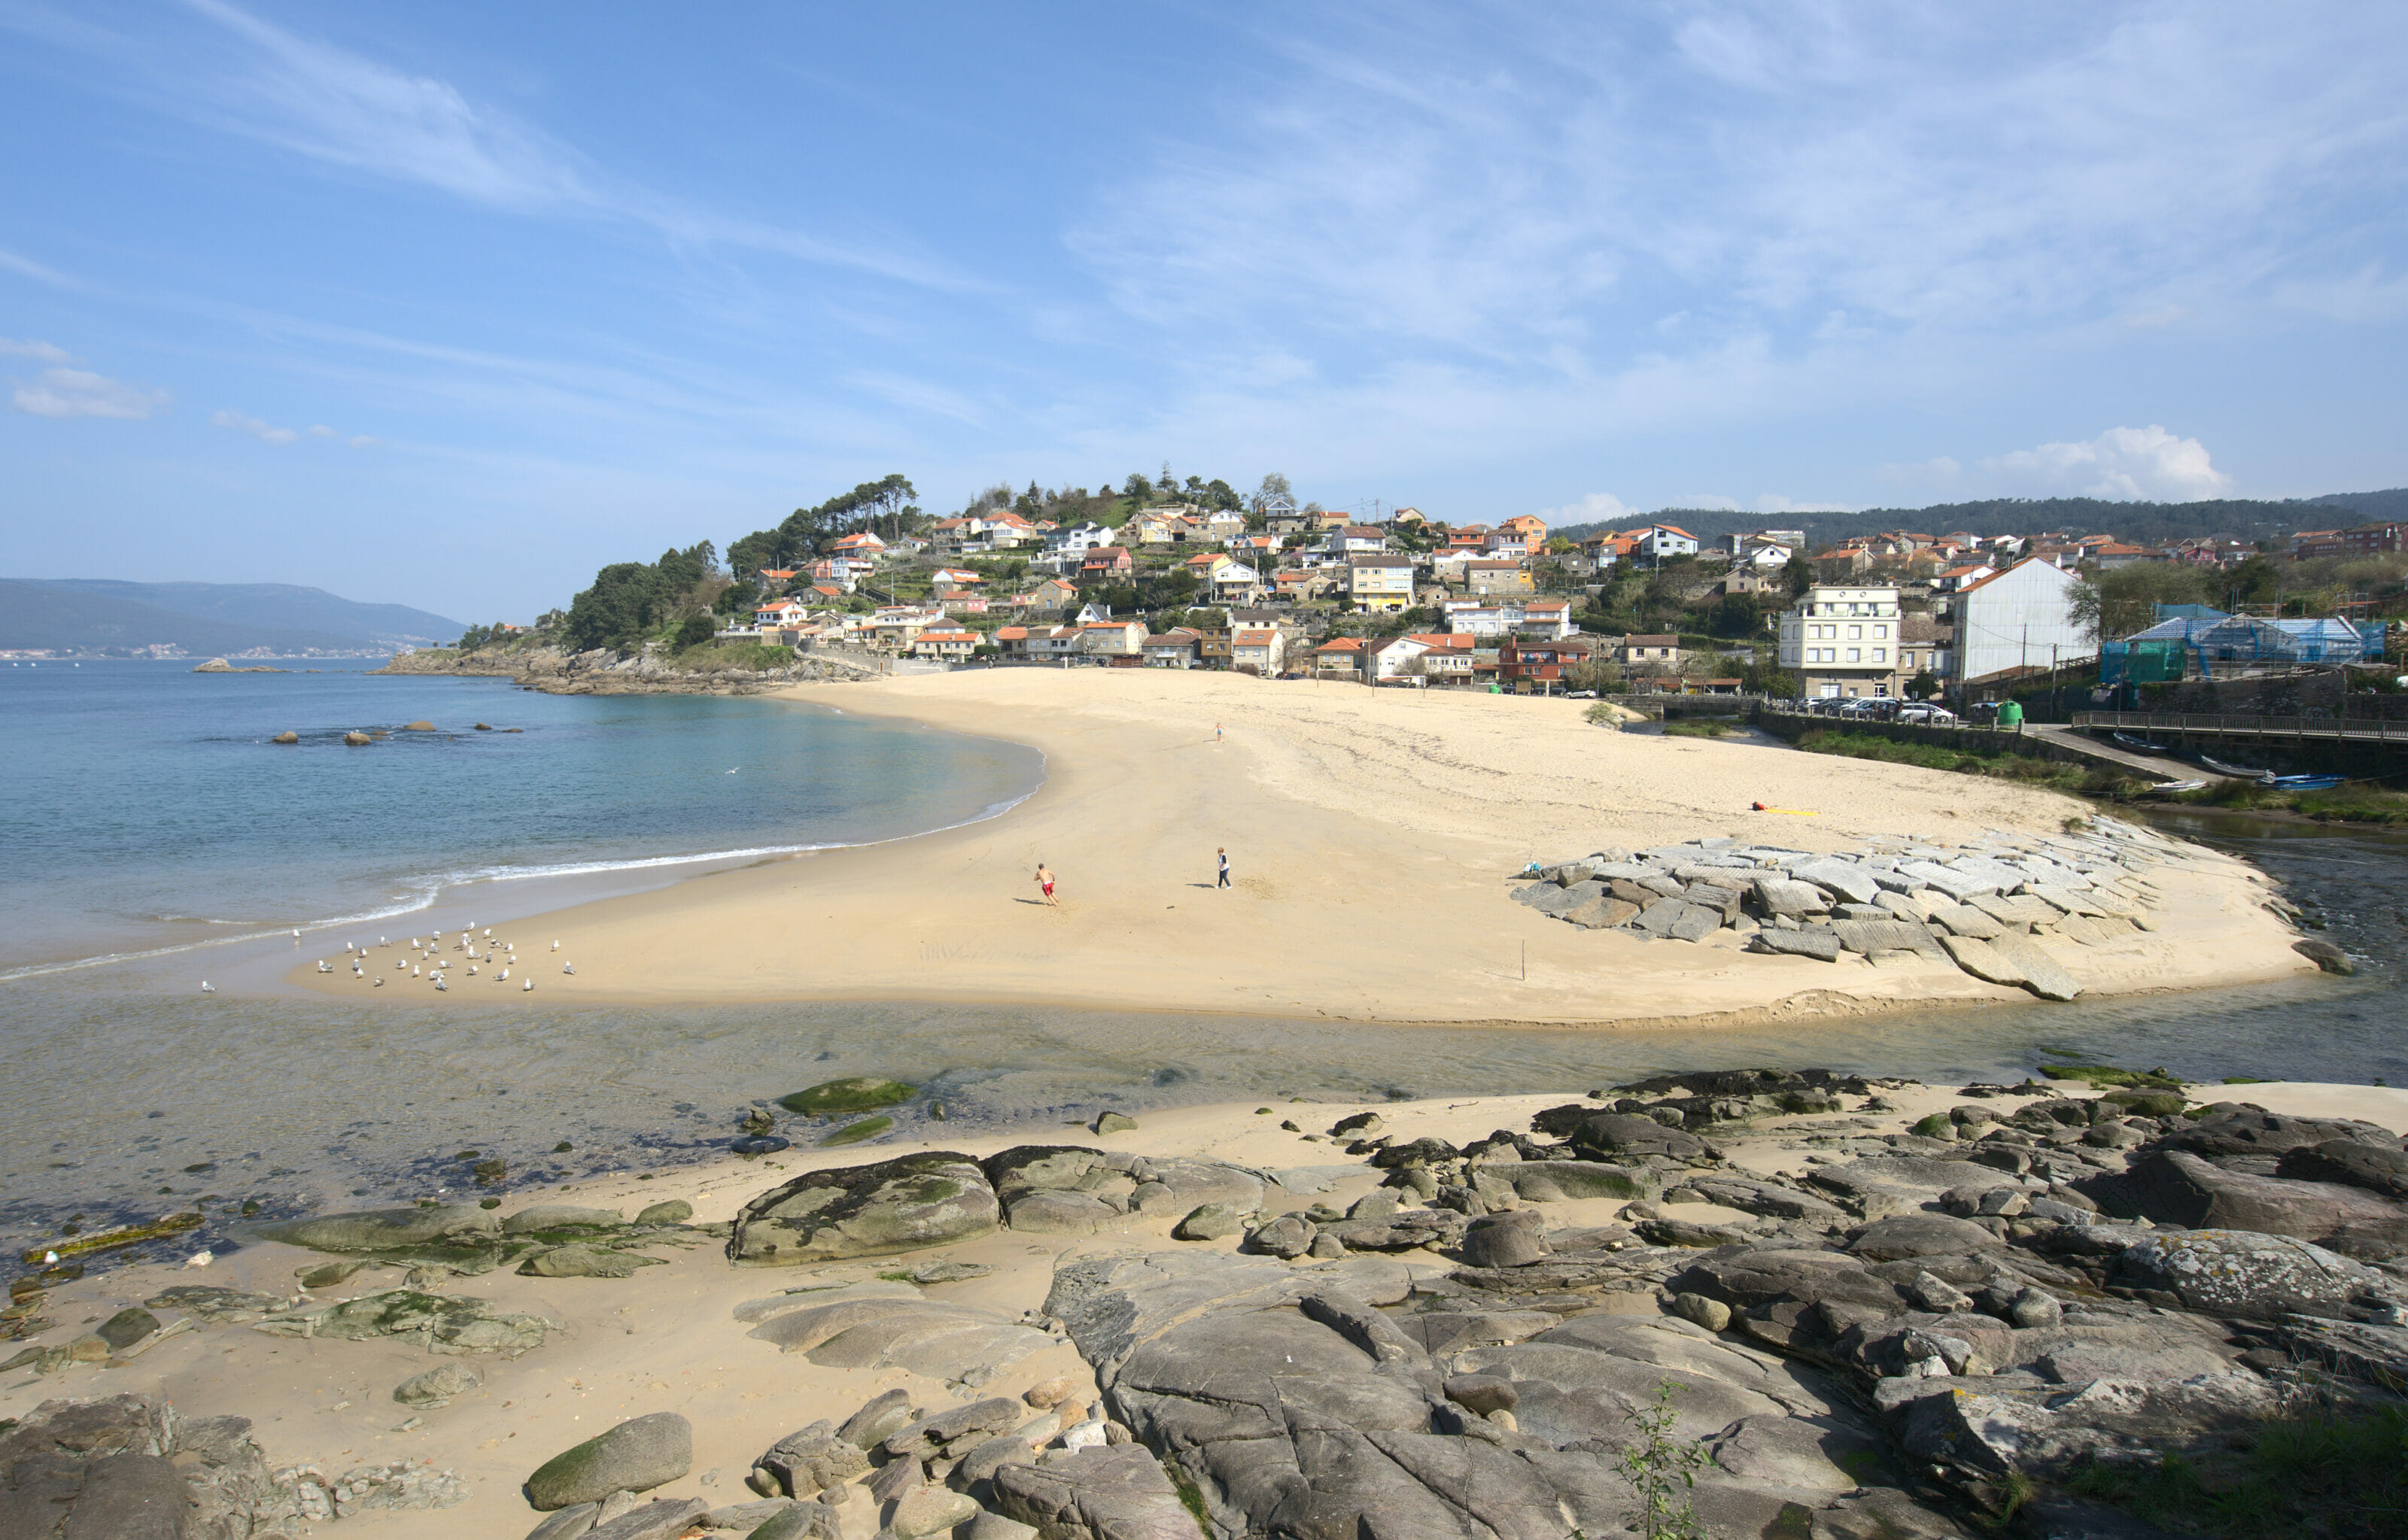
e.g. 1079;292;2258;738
491;472;2408;700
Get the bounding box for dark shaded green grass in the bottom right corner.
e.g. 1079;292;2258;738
2073;1408;2408;1540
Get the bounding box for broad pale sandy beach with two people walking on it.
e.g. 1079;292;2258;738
291;669;2312;1025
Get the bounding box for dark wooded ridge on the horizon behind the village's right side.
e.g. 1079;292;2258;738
1553;488;2408;551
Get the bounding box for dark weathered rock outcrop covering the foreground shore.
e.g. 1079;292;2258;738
19;1071;2408;1540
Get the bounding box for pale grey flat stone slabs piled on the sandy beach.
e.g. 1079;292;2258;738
1513;818;2312;1001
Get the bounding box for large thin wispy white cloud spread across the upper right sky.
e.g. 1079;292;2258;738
1067;0;2408;469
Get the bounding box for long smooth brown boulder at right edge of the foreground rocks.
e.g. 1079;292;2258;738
2075;1150;2408;1261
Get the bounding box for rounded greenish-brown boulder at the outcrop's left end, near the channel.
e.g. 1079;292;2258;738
727;1150;999;1265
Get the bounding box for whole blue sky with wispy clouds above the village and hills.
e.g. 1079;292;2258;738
0;0;2408;618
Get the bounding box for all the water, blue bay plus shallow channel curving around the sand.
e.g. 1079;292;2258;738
0;664;2408;1249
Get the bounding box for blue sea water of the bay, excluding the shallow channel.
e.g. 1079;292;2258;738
0;662;1043;986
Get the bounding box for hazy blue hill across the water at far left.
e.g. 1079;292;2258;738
0;578;467;657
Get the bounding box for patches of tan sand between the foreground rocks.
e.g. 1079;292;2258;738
0;1083;2408;1540
